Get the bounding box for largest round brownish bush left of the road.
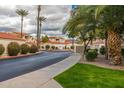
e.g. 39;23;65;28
7;42;20;56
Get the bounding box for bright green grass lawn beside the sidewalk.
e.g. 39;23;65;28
54;63;124;88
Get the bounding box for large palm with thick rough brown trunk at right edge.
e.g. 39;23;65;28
96;6;124;65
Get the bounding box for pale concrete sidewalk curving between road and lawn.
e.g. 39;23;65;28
0;54;81;88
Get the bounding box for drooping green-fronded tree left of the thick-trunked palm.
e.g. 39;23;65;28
63;6;97;54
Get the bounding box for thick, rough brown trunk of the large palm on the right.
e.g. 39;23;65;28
108;31;121;65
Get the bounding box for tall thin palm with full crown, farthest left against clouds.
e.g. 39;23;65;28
16;9;29;38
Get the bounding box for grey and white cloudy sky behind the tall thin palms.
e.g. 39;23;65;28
0;5;70;34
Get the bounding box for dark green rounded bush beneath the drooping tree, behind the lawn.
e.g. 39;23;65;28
86;49;98;61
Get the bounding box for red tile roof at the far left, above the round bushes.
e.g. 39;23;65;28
0;32;25;41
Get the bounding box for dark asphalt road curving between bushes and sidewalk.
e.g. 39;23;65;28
0;52;71;82
